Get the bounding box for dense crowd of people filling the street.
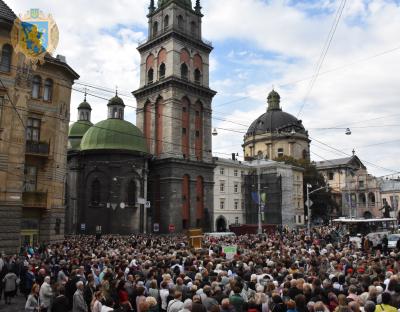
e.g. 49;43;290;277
0;227;400;312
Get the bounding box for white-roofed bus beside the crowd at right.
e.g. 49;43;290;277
332;218;398;247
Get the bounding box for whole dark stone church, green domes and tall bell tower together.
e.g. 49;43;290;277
67;0;216;234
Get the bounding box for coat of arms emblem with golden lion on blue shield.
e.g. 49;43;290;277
11;9;59;68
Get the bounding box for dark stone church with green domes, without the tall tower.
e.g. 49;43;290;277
66;96;150;234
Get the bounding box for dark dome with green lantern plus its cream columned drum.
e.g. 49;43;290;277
242;90;311;160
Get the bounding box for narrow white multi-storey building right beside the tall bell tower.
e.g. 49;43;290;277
212;157;249;232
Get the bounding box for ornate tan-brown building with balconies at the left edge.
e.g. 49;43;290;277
0;0;79;253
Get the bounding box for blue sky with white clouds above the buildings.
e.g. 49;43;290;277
6;0;400;176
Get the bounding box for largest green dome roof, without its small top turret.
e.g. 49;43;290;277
81;119;147;153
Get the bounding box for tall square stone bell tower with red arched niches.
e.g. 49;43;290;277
133;0;216;233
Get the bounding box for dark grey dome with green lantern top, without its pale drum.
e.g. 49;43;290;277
246;90;306;136
